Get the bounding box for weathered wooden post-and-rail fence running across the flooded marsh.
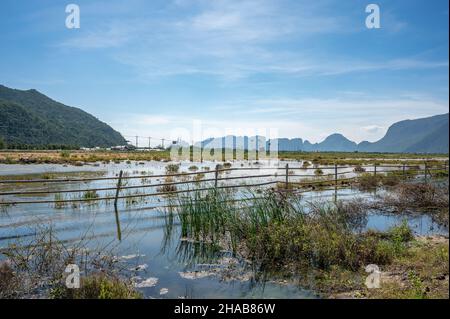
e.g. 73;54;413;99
0;163;448;206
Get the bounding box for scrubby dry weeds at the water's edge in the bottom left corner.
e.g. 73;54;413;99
0;226;132;298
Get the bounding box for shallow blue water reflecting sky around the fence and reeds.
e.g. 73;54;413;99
0;162;448;298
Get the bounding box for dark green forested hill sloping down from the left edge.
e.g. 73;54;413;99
0;85;126;147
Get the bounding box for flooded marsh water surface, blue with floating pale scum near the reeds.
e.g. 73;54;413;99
0;162;448;298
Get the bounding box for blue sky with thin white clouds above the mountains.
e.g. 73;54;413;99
0;0;449;142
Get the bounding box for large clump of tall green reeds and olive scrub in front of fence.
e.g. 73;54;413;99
166;190;410;270
